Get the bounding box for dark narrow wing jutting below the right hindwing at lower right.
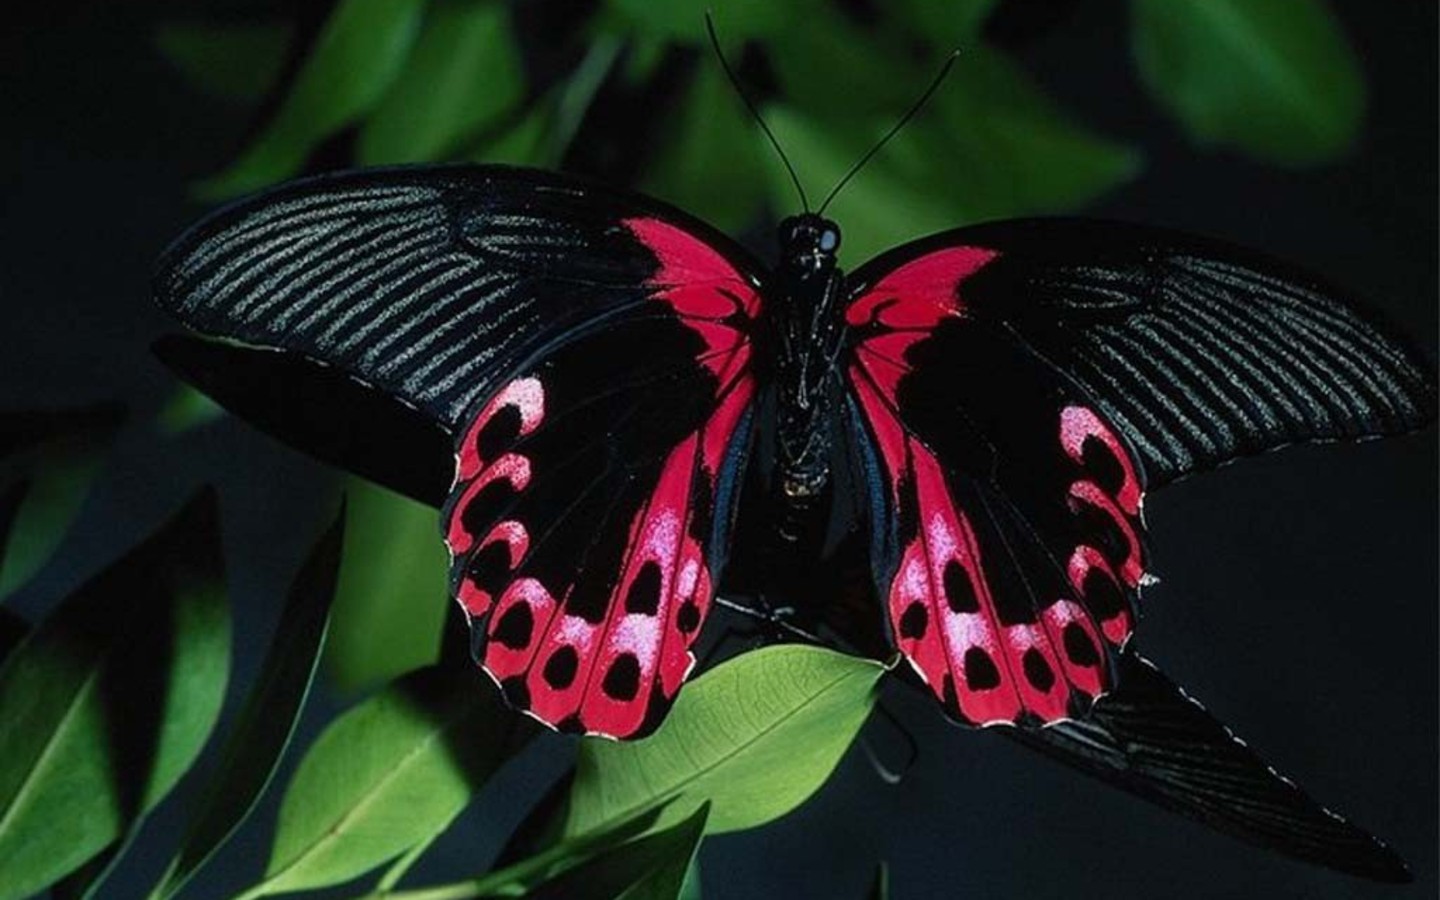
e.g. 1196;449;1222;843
1002;649;1411;881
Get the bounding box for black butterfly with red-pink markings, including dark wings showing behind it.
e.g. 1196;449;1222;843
156;166;1436;877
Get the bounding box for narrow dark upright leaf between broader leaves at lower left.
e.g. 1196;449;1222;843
151;510;344;897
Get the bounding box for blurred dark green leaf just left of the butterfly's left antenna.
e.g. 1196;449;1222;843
642;65;765;232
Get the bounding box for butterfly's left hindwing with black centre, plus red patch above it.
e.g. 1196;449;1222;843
444;217;759;737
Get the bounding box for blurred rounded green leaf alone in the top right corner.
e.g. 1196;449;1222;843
1132;0;1365;166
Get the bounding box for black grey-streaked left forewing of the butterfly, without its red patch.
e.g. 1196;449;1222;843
154;166;760;431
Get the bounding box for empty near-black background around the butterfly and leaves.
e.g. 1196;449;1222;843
0;0;1437;899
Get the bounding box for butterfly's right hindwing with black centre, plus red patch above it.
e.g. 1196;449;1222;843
845;246;1145;724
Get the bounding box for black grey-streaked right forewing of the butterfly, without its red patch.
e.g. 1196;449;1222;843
852;219;1436;490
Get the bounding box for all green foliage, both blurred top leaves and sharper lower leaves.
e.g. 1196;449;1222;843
0;0;1365;900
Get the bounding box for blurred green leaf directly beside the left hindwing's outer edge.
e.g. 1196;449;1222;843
324;478;451;691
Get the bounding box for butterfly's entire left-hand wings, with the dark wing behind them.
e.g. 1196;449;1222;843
156;167;760;737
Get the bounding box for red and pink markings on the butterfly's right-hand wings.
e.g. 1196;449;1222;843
847;248;1142;726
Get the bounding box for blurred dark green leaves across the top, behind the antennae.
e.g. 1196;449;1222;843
165;0;1364;254
